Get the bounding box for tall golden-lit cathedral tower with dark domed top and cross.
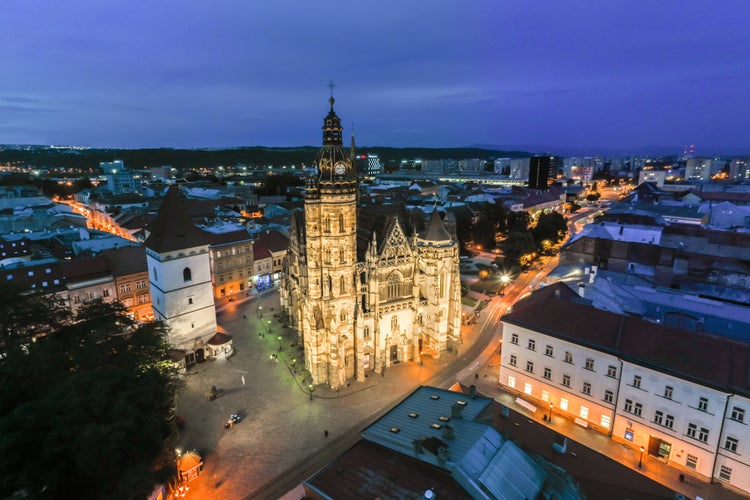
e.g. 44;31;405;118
303;95;357;387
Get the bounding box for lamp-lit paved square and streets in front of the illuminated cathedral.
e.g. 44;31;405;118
177;278;743;500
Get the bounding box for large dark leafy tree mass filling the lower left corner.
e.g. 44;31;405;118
0;292;176;498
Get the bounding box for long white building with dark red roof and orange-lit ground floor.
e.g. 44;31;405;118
499;283;750;492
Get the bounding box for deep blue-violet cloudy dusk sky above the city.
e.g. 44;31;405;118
0;0;750;154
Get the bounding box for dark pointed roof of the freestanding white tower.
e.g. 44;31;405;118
145;186;208;253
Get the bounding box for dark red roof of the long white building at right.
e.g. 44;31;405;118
502;283;750;395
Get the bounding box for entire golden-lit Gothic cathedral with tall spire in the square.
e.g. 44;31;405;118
280;94;461;388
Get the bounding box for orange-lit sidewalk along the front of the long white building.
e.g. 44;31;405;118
459;349;747;500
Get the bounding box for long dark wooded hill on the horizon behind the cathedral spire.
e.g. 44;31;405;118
0;145;528;169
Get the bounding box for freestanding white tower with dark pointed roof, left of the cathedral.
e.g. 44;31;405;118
145;186;231;365
